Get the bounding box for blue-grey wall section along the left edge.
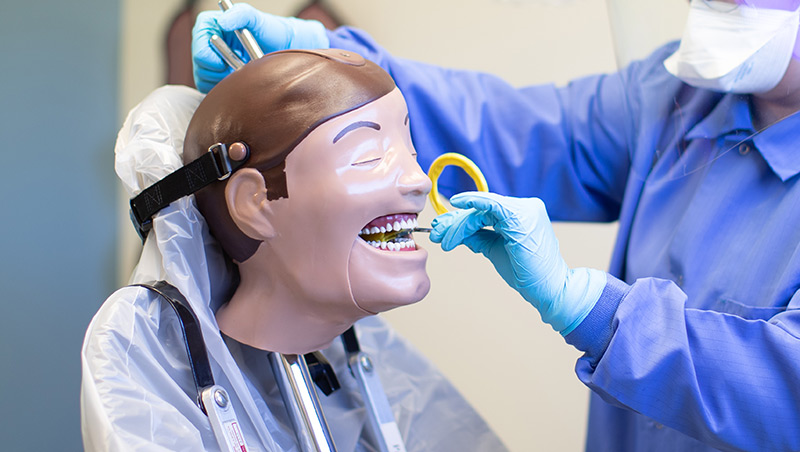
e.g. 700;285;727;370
0;0;121;451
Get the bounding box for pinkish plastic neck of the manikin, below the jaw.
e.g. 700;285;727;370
216;252;365;354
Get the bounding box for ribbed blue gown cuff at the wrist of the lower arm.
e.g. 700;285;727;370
564;275;631;362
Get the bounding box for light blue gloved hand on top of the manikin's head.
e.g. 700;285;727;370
192;3;330;93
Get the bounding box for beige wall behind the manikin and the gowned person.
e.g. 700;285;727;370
120;0;686;452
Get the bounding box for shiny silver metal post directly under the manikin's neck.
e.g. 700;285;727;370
269;352;336;452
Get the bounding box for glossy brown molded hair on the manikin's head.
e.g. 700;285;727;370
183;49;395;262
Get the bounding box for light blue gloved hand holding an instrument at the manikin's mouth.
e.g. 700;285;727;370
430;192;607;336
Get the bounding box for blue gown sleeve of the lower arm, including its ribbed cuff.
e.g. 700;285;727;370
566;277;800;451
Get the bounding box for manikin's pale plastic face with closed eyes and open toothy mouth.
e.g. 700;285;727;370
258;89;431;322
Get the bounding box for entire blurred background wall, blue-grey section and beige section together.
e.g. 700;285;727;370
0;0;686;451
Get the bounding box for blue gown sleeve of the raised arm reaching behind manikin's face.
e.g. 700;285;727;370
330;27;637;221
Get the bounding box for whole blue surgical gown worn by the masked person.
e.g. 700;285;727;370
330;28;800;452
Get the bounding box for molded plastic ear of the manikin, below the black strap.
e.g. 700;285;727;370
225;168;275;240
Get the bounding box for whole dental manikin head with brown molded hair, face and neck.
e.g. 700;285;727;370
183;50;431;354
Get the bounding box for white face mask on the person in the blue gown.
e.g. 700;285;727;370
664;0;800;94
